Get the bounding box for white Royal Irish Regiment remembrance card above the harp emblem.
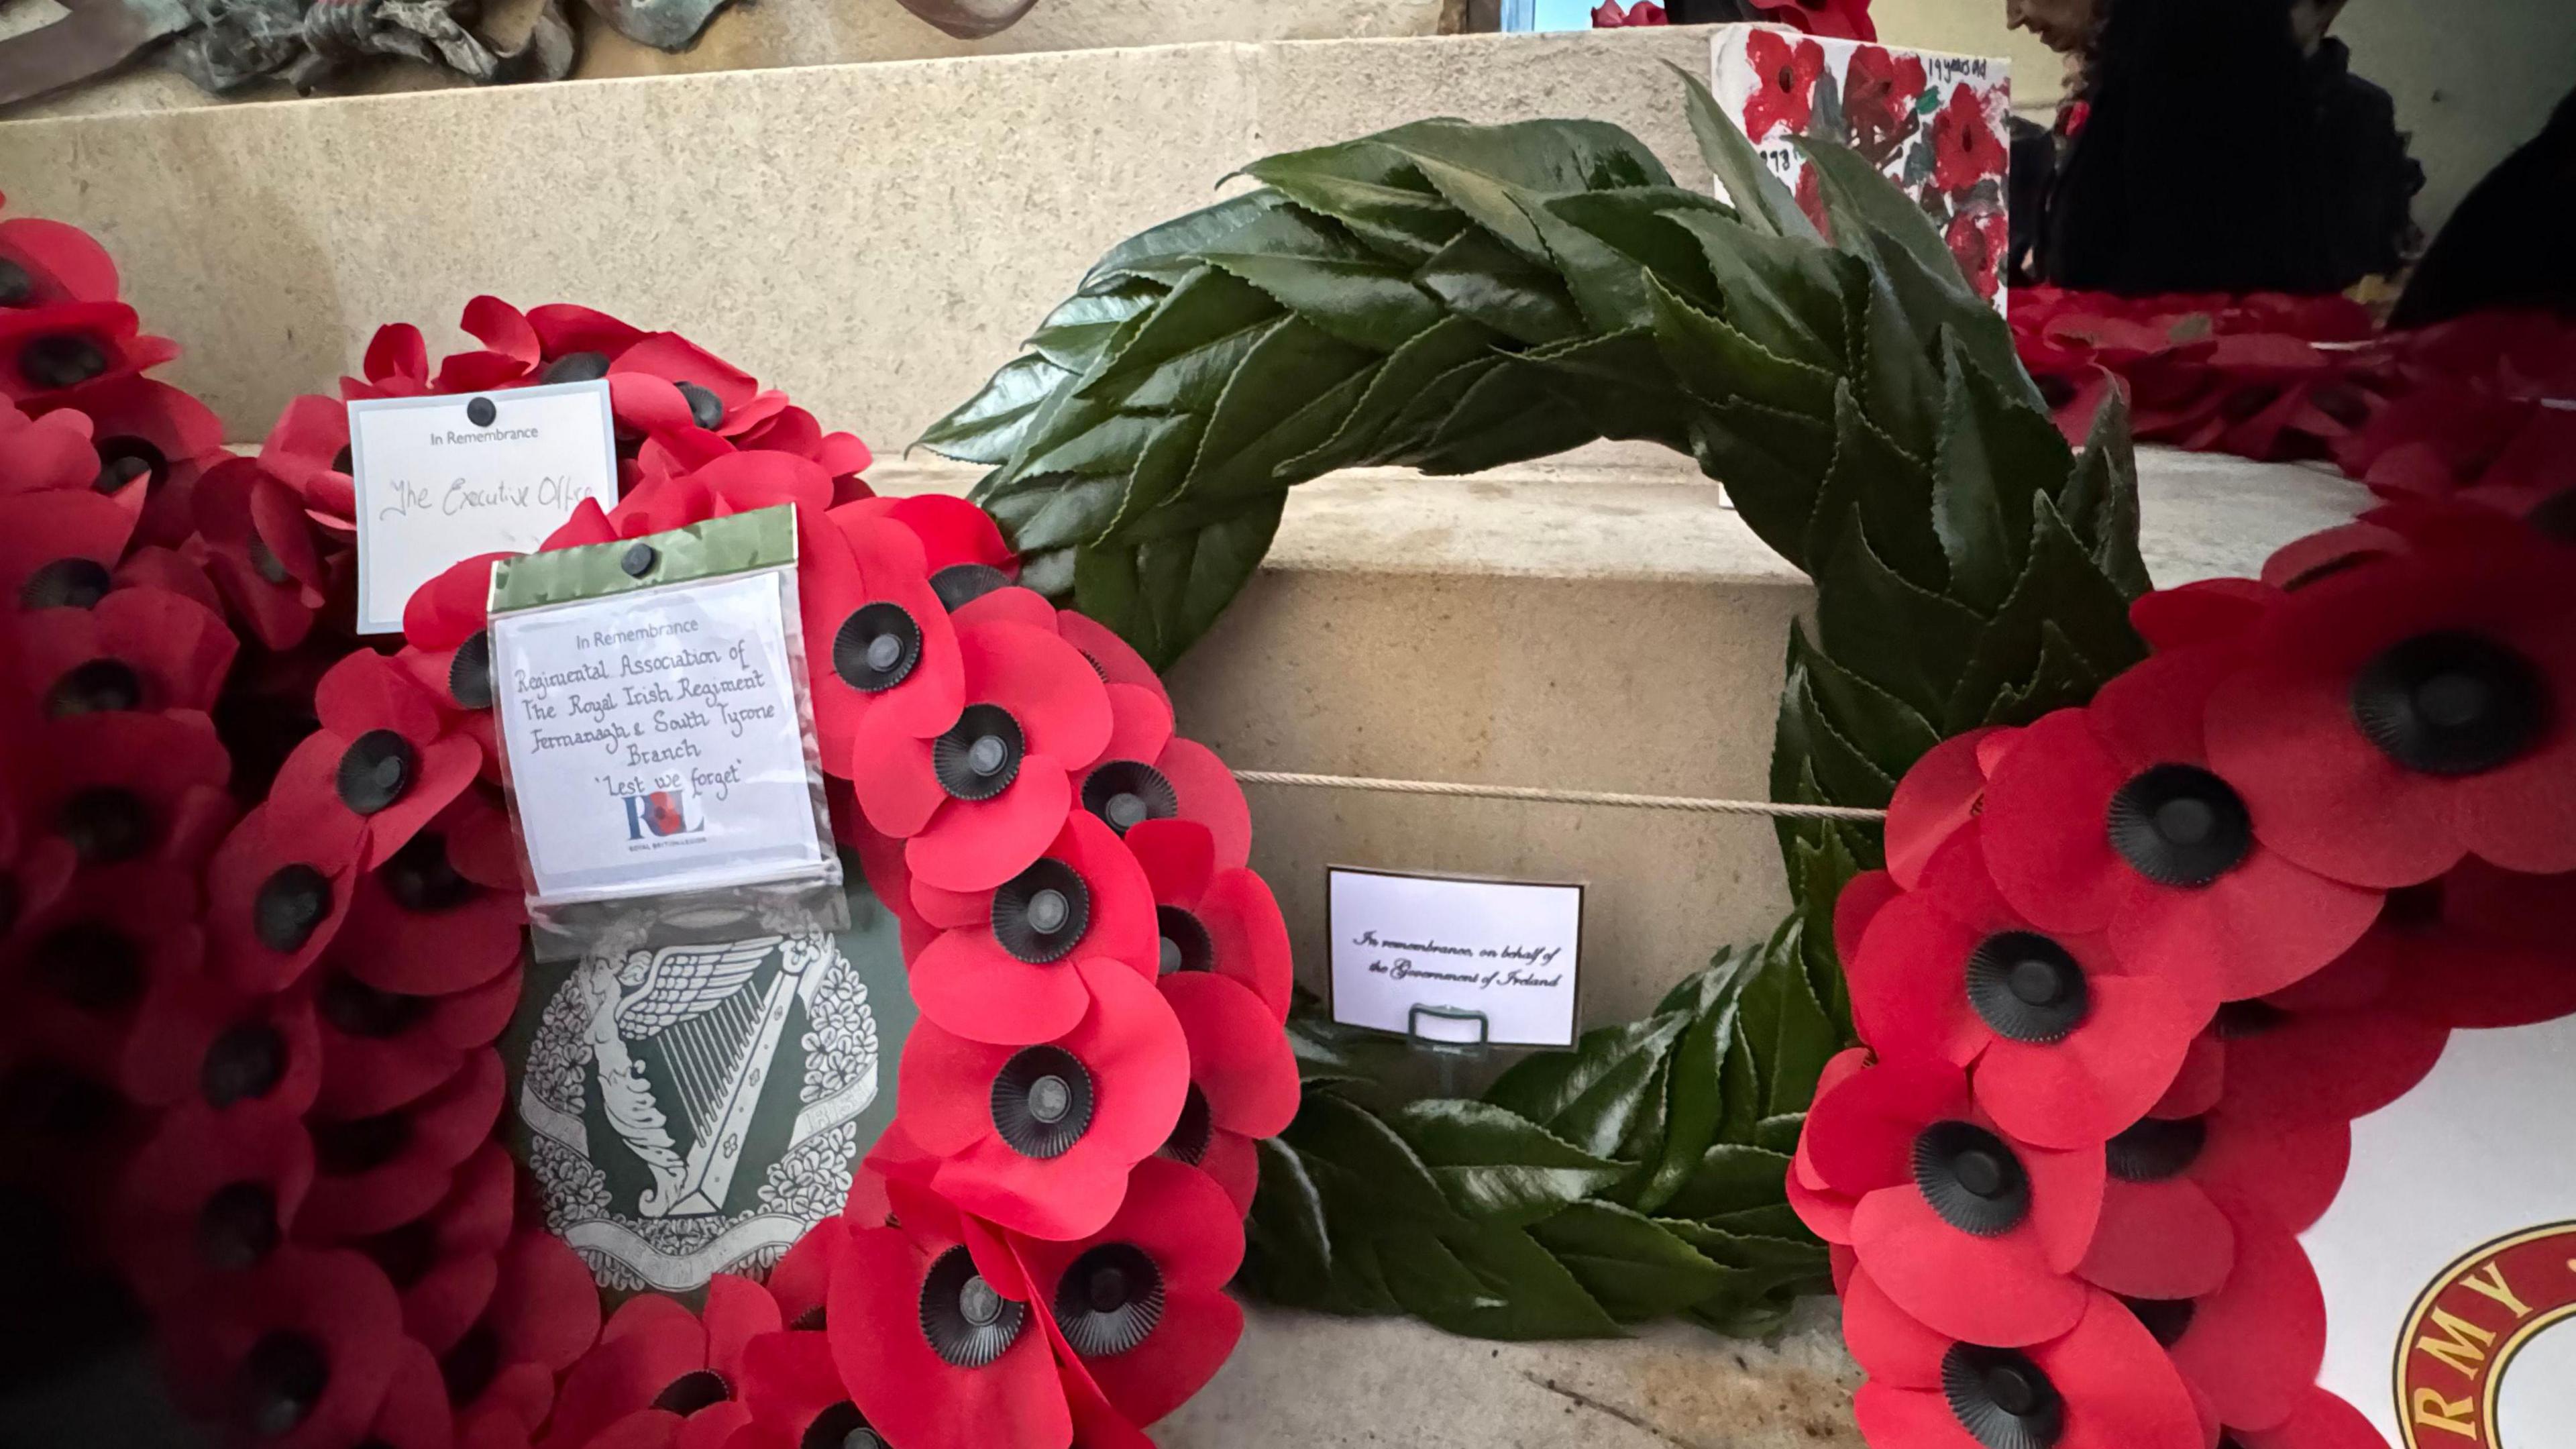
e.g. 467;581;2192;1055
492;572;824;902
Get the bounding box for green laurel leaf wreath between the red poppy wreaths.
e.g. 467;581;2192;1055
922;64;2146;1338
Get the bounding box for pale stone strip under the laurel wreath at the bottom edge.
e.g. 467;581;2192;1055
1154;1299;1860;1449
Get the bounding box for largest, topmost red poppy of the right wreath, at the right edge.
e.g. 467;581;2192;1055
2205;523;2576;890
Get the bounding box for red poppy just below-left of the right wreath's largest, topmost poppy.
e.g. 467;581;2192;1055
1981;645;2380;1000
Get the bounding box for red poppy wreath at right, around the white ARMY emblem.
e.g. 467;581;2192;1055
1788;492;2576;1449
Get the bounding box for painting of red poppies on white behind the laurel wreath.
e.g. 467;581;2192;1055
1711;25;2012;309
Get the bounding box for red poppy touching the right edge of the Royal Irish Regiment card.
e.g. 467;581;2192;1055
796;508;966;773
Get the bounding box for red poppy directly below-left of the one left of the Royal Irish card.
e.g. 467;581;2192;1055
206;804;363;993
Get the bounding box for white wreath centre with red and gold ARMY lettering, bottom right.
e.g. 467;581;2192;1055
2300;1016;2576;1449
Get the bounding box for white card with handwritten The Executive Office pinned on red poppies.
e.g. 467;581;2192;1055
347;379;619;634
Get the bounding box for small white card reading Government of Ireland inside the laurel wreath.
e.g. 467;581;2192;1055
1324;866;1585;1046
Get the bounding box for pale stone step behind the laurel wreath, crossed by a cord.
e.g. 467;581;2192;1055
871;446;2362;1026
